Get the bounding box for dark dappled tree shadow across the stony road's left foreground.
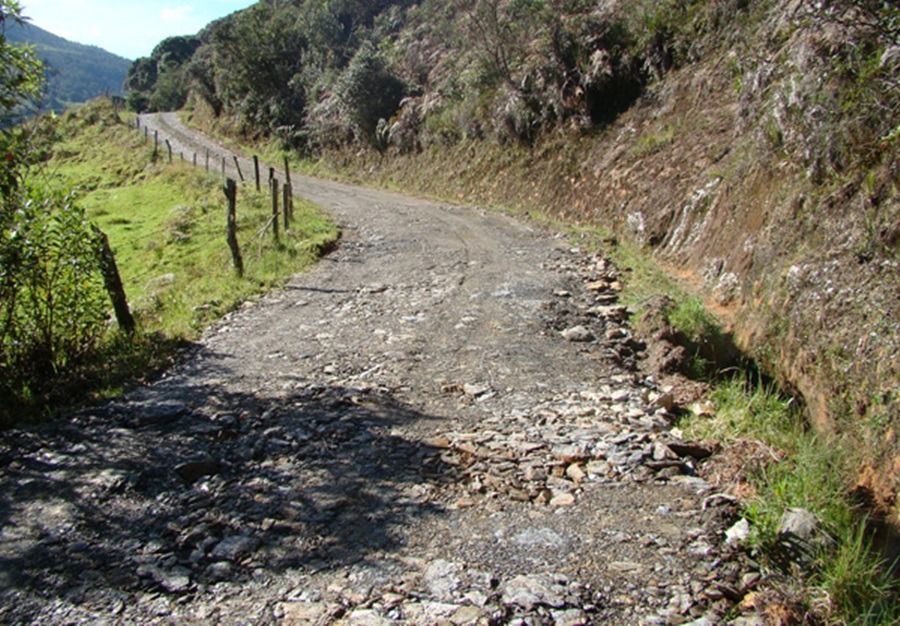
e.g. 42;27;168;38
0;352;454;622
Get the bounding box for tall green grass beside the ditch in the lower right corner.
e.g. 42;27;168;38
681;378;900;625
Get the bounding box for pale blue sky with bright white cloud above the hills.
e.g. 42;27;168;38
21;0;255;59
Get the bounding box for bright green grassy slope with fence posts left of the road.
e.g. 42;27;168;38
12;101;339;416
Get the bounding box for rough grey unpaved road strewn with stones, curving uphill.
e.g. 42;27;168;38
0;115;740;626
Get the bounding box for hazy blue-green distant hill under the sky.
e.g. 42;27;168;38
6;24;131;111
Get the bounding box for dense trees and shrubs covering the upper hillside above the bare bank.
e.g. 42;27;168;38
127;0;900;166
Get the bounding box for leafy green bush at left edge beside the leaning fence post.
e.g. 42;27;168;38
0;184;108;418
